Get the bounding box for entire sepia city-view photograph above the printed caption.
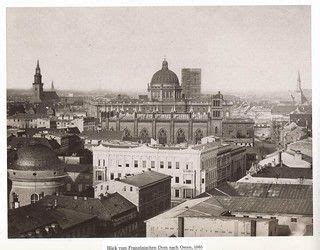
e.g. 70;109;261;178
2;1;315;242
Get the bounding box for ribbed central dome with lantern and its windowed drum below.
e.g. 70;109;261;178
148;60;182;101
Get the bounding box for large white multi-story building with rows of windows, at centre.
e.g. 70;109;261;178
92;142;246;200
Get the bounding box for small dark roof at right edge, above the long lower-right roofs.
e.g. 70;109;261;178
252;164;312;179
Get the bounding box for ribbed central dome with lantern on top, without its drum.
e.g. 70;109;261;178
150;60;179;86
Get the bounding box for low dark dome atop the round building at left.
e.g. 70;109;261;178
11;144;63;171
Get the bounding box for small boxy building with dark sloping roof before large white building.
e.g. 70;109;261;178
95;170;171;219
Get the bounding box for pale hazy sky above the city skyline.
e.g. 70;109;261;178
7;6;311;92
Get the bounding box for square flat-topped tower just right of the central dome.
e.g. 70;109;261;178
181;68;201;99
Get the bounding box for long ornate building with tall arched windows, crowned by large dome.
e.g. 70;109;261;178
86;60;223;144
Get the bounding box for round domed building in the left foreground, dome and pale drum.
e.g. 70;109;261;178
8;144;66;208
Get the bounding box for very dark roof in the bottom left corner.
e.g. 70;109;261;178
8;204;57;237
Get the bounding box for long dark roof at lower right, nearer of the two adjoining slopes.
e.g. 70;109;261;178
210;196;313;215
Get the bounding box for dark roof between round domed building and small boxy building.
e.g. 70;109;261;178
39;193;136;220
